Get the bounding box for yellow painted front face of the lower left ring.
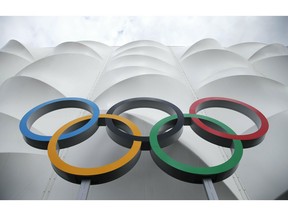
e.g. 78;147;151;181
48;114;141;177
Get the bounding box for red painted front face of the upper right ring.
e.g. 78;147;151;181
189;97;269;141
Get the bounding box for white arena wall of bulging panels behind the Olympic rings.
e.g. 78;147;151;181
0;39;288;200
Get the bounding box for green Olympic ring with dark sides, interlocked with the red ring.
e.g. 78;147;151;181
150;114;243;183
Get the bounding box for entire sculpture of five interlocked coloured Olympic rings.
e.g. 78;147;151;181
19;97;269;184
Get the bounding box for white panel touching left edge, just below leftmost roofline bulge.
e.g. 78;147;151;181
0;52;30;85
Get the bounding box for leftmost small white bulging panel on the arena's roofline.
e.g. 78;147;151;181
1;40;33;62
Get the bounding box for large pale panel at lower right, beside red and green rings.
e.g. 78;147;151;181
238;110;288;200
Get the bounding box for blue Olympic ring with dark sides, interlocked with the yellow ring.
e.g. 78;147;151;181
19;97;100;149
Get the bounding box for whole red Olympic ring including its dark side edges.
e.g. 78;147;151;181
189;97;269;148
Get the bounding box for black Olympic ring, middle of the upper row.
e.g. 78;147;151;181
106;97;184;150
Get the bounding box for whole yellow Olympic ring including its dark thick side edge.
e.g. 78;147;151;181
48;114;141;184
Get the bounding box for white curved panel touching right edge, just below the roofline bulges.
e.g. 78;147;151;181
253;55;288;86
